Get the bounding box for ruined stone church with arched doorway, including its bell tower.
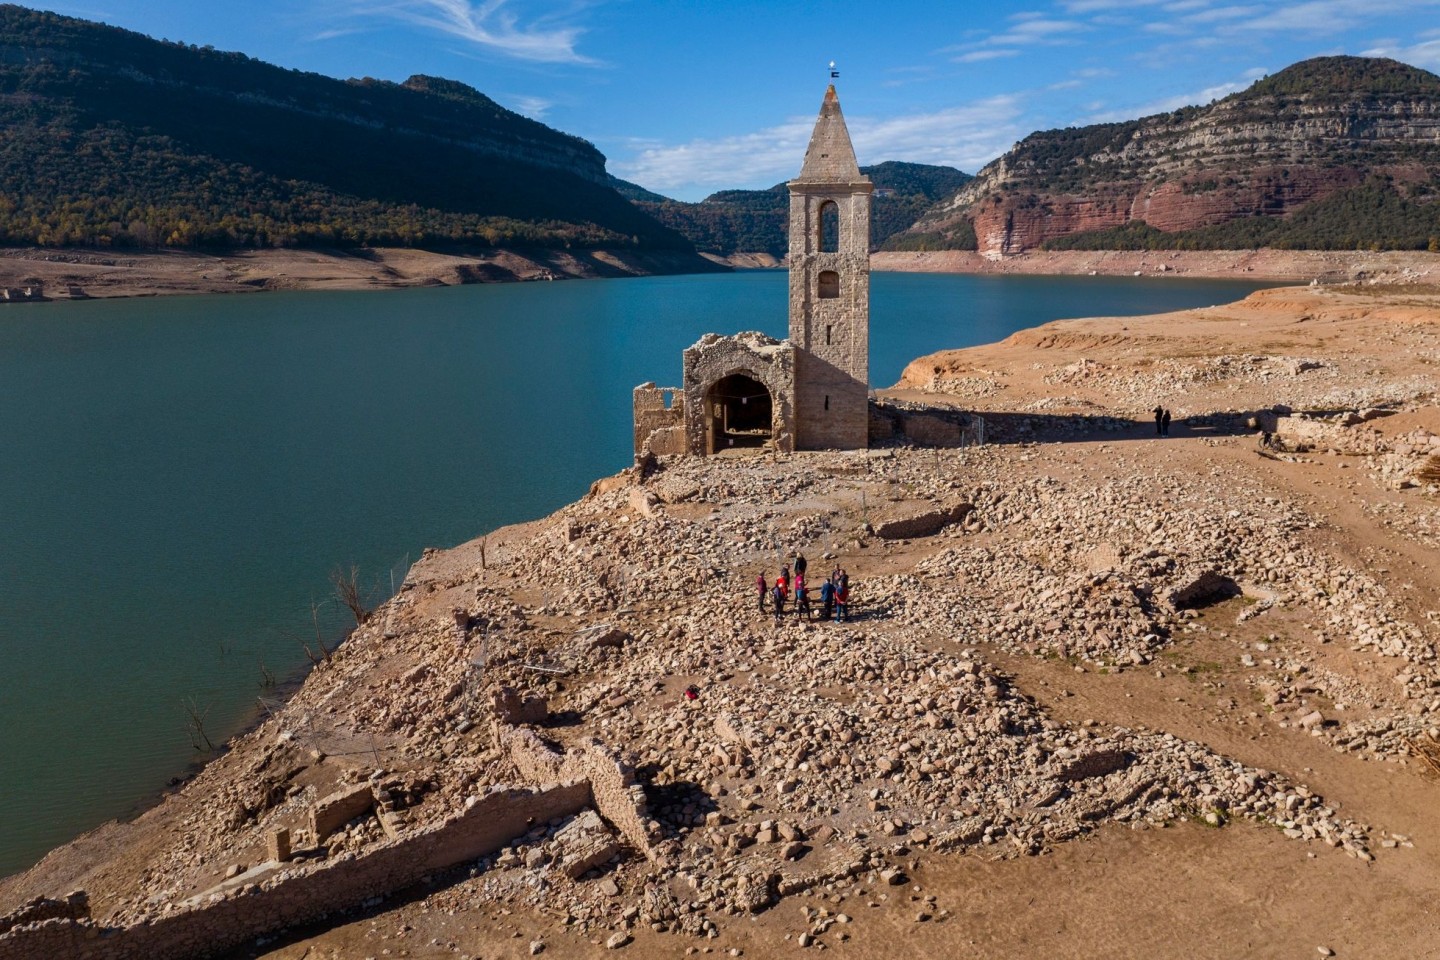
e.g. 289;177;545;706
635;85;874;458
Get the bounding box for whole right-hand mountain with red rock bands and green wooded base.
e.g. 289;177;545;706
890;56;1440;256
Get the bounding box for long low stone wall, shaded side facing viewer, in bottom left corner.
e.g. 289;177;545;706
0;782;590;960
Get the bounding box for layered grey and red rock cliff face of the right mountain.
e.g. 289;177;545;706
910;58;1440;258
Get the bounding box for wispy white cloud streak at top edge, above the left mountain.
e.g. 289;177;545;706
328;0;593;63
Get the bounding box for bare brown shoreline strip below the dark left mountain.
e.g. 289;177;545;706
0;248;719;299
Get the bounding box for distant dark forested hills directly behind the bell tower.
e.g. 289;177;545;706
621;160;971;258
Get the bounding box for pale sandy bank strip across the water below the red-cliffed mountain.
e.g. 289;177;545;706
870;250;1440;284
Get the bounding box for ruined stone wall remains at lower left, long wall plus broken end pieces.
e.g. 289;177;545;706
0;720;654;960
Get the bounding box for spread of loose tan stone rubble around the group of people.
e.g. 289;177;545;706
81;426;1440;936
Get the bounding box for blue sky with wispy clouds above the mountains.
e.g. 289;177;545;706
30;0;1440;200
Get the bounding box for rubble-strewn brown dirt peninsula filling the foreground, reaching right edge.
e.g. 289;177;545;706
0;285;1440;960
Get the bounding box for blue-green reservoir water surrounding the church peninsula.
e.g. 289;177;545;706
0;271;1259;892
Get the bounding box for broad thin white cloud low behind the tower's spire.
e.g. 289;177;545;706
612;95;1028;200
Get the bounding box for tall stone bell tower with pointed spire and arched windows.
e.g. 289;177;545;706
788;83;874;450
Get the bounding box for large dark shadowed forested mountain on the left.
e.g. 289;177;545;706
0;4;688;249
